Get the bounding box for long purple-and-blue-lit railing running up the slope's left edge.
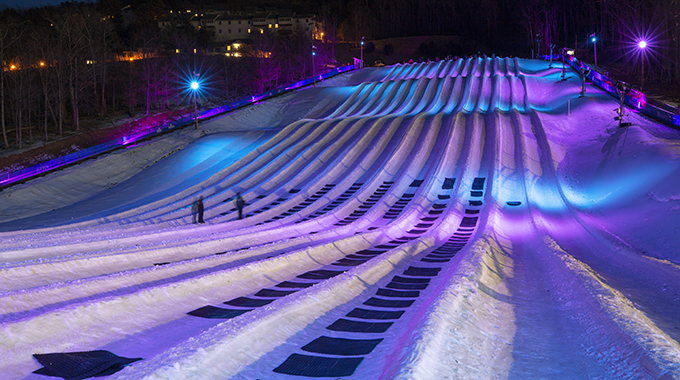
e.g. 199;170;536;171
0;65;355;188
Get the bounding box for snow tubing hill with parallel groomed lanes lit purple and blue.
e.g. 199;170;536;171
0;58;680;379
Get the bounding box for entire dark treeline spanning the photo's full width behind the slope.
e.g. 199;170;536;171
0;0;680;148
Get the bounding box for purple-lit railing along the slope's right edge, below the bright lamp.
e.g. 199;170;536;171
559;55;680;128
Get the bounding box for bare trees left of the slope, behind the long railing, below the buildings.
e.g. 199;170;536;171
0;0;332;149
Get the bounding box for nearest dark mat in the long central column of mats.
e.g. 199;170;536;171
274;354;364;377
